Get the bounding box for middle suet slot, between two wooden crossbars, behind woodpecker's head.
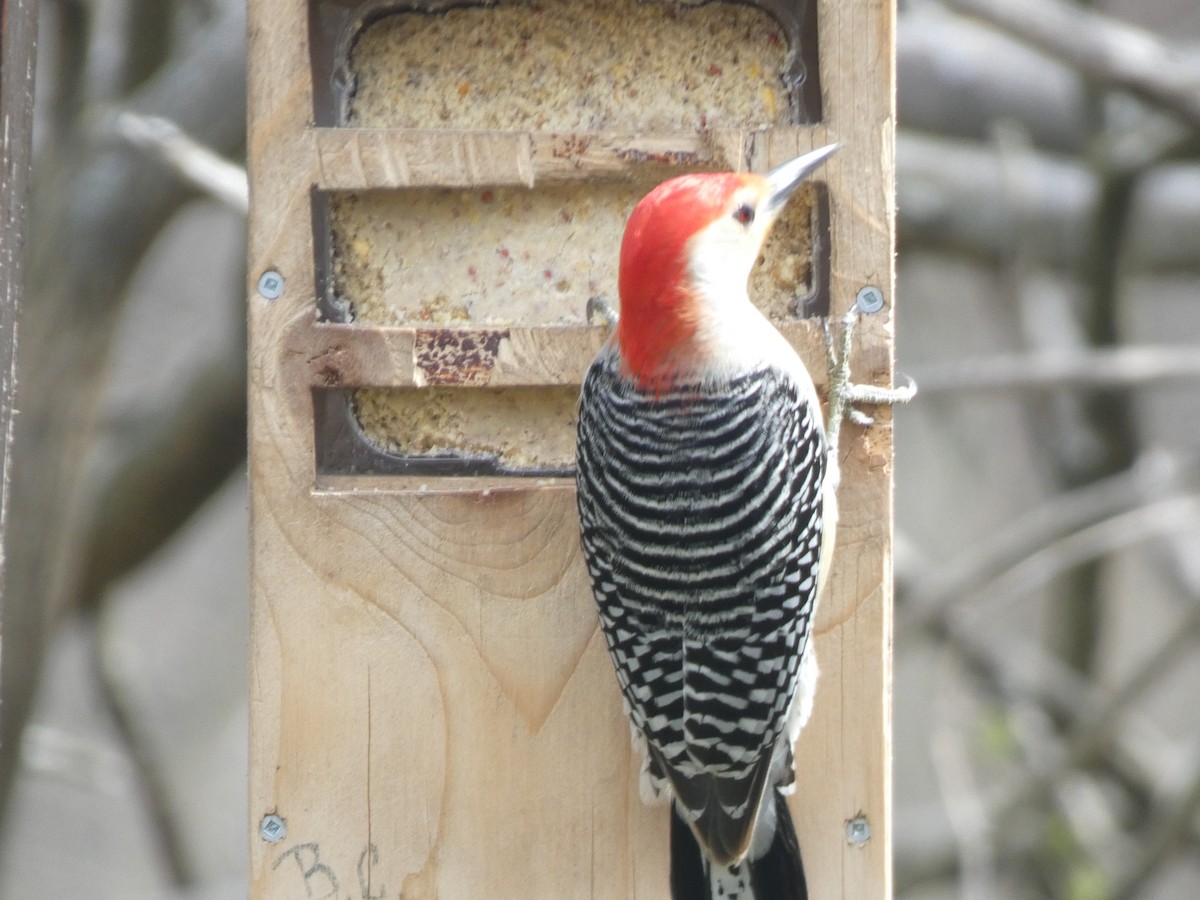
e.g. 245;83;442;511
313;179;829;328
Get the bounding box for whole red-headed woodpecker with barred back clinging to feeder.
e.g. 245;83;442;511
577;146;838;900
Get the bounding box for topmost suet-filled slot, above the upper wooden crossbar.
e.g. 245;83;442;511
308;0;821;132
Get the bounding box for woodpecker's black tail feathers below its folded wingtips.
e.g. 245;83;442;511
671;790;809;900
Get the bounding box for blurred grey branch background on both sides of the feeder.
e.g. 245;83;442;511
0;0;1200;900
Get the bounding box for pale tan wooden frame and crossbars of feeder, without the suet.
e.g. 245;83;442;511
248;0;894;900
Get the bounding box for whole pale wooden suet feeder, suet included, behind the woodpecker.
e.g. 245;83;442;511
248;0;894;900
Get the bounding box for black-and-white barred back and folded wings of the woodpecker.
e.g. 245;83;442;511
577;353;826;897
